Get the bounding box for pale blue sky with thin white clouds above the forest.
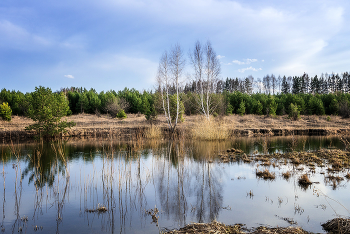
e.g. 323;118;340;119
0;0;350;92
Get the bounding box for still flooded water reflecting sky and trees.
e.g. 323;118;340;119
0;137;350;233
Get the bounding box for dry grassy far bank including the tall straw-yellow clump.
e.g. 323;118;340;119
0;114;350;140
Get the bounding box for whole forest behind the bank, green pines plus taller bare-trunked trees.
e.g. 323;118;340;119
0;72;350;120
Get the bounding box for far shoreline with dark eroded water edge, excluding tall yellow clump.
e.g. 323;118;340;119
0;114;350;143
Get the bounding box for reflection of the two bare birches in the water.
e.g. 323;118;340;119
154;143;223;225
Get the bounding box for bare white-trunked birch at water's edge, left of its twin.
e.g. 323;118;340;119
157;44;185;132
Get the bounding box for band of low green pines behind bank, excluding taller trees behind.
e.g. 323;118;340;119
0;84;350;118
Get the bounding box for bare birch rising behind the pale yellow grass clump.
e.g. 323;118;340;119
190;41;221;119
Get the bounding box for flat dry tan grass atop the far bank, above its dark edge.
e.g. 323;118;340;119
0;114;350;135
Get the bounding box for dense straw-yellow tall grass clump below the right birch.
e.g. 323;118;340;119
191;117;232;141
